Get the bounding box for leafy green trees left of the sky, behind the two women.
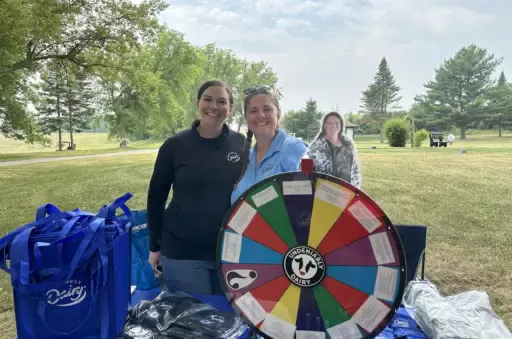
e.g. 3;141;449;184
0;0;280;149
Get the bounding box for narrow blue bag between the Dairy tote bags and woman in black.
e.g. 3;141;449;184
132;210;158;291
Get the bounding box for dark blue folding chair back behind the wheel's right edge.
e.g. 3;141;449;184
395;225;427;285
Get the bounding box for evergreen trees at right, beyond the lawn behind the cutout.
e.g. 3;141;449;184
348;44;512;140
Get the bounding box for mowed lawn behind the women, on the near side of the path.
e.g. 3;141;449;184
0;135;512;338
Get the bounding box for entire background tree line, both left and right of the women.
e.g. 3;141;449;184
0;0;512;148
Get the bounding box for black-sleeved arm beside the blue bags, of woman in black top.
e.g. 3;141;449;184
147;139;174;252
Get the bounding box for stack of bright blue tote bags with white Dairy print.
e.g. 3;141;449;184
0;193;132;339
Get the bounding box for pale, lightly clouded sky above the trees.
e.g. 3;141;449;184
144;0;512;113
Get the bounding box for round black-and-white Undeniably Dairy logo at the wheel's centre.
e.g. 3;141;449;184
283;246;325;287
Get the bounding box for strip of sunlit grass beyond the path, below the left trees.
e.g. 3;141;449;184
0;133;163;161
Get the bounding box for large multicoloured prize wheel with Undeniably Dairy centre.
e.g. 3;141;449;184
217;172;406;339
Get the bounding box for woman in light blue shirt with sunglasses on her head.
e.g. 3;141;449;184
231;86;308;204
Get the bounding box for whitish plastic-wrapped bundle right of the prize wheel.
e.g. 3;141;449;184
404;280;512;339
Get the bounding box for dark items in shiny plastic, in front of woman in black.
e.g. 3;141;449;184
118;292;247;339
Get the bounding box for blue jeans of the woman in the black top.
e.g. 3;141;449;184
162;256;224;295
